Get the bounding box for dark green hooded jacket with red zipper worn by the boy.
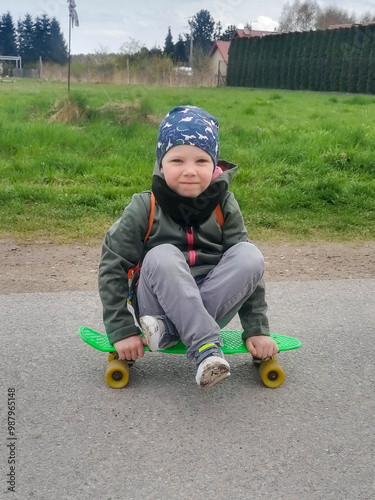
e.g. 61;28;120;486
99;161;269;344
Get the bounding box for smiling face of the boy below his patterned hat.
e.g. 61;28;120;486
160;144;214;198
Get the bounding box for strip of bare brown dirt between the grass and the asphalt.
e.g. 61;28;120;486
0;239;375;294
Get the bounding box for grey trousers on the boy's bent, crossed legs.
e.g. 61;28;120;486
137;242;264;359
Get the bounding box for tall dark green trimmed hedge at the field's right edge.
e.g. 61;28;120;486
227;24;375;94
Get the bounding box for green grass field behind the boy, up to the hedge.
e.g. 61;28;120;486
0;80;375;242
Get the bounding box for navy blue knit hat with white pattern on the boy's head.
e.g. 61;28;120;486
156;106;219;168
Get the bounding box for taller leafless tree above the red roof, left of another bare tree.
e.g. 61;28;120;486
279;0;321;31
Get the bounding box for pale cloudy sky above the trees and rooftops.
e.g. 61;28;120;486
0;0;375;54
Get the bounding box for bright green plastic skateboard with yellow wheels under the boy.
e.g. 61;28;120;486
79;326;301;389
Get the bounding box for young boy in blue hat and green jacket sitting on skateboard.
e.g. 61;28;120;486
99;106;278;387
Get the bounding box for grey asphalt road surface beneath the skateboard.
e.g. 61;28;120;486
0;279;375;500
